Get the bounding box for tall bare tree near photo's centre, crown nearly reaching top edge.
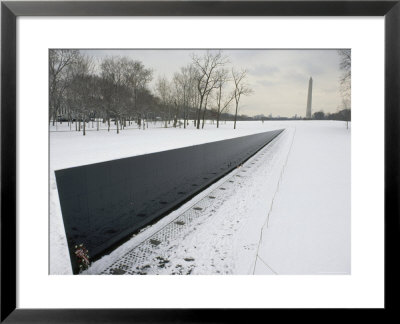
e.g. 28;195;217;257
192;51;228;129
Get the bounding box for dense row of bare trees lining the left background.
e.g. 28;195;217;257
49;49;252;135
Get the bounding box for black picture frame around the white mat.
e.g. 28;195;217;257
0;0;400;323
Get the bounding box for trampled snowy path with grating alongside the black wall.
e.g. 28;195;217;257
85;128;294;274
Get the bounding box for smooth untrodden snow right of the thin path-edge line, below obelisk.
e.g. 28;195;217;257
255;122;351;274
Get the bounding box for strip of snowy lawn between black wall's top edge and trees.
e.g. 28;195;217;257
50;121;279;170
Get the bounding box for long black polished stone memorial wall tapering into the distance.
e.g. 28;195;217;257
55;130;282;273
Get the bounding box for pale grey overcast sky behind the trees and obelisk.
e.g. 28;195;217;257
81;50;341;117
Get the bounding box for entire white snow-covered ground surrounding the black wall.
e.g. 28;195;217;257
50;121;350;274
